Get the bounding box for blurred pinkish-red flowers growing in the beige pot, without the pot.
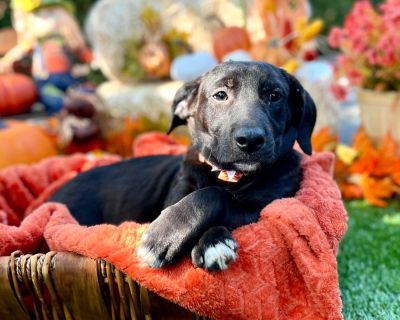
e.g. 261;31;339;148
328;0;400;92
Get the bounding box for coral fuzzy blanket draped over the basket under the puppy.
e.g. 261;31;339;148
0;133;347;320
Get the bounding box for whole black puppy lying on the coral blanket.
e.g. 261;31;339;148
50;62;316;270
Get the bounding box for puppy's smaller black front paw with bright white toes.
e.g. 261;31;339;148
192;227;238;271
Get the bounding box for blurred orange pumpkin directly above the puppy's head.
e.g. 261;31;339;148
213;27;251;61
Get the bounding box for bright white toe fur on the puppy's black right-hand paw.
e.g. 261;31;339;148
204;239;237;270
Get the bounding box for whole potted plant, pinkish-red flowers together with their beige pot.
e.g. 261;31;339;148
329;0;400;143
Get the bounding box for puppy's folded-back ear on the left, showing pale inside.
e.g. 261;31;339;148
167;78;201;134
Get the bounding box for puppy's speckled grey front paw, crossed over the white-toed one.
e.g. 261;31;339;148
137;207;191;268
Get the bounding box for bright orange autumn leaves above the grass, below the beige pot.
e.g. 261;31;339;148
312;128;400;207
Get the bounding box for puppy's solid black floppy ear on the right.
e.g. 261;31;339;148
284;71;317;155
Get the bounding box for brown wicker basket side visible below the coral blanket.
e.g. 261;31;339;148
0;252;209;320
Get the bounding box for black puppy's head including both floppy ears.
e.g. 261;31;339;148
169;62;316;172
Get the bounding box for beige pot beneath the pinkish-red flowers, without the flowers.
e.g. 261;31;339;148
358;88;400;144
